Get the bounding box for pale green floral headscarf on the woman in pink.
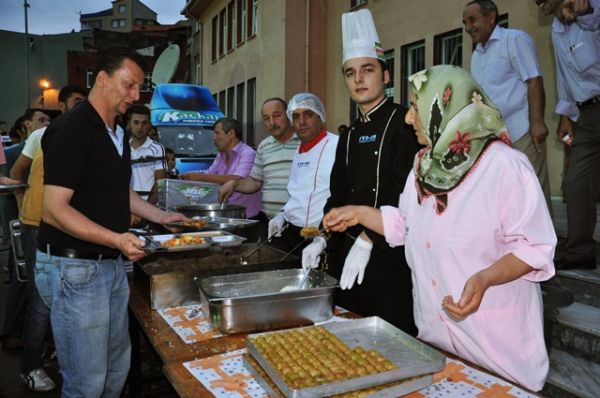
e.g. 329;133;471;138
409;65;510;213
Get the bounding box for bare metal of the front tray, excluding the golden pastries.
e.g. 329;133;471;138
246;316;446;398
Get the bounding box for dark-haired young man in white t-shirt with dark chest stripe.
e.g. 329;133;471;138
127;104;167;204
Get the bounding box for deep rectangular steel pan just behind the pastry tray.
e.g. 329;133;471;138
196;269;339;334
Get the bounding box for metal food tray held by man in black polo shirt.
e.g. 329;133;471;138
142;231;246;252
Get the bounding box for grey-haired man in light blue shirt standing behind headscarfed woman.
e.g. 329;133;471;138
463;0;552;214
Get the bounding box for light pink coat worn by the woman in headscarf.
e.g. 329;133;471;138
381;143;556;391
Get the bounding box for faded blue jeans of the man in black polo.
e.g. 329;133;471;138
35;250;131;398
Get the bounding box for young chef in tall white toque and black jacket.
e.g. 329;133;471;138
302;9;417;335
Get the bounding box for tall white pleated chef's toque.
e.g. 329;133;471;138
342;9;383;65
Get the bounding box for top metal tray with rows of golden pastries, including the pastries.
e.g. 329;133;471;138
246;317;445;398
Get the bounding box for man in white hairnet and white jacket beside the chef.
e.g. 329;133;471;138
268;93;338;252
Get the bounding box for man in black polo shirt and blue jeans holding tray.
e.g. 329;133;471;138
35;49;186;397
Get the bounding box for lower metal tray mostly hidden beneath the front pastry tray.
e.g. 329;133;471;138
242;354;433;398
